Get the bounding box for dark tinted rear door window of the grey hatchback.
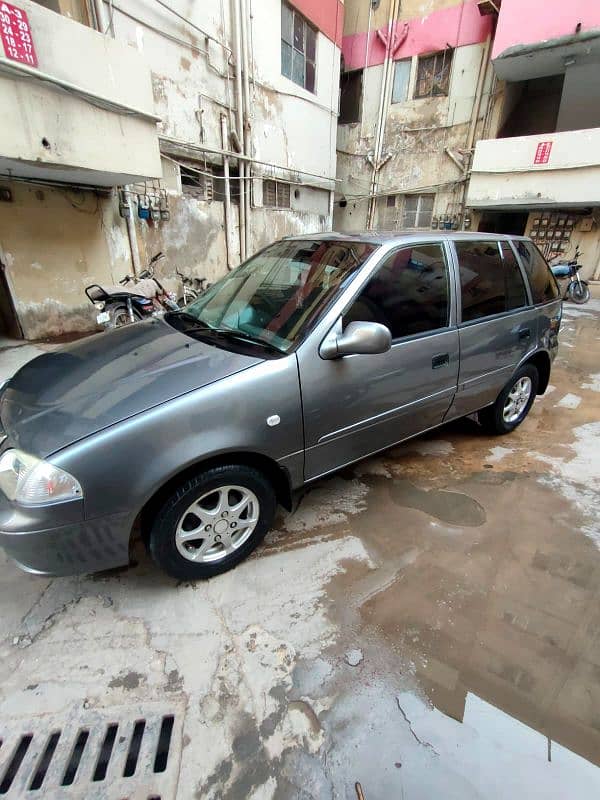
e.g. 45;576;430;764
454;241;527;322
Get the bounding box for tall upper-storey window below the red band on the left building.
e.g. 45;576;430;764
281;3;317;93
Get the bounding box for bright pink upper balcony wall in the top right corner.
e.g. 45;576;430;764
492;0;600;58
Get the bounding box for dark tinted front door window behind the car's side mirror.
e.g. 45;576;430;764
344;244;449;339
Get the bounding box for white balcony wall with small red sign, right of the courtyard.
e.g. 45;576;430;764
467;128;600;210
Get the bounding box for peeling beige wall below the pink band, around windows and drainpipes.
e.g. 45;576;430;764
334;36;498;231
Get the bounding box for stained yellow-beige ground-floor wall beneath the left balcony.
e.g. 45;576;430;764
0;182;130;339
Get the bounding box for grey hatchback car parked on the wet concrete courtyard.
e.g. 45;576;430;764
0;232;562;579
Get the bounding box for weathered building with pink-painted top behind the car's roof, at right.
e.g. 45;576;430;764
334;0;600;278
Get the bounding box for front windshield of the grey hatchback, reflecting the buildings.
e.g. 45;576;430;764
169;240;377;352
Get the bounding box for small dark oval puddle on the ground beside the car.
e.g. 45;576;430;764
390;480;486;527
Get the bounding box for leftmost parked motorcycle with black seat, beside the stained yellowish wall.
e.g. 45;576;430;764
85;252;179;328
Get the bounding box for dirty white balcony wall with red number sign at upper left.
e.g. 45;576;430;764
0;0;161;186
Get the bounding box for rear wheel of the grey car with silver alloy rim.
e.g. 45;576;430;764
478;364;540;436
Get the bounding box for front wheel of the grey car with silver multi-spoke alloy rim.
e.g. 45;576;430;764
148;465;277;580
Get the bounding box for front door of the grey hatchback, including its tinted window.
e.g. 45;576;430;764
298;236;459;480
